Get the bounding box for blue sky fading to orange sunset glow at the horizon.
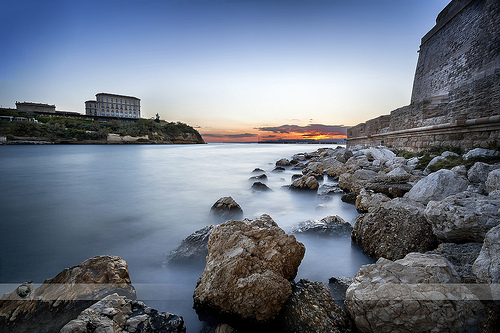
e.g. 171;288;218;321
0;0;449;142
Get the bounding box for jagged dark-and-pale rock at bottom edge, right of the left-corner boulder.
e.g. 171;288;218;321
60;294;186;333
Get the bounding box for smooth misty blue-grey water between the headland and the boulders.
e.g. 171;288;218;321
0;144;370;332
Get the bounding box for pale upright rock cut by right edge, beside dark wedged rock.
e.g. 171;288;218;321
472;225;500;283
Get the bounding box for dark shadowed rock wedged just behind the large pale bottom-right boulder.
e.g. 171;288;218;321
427;243;483;283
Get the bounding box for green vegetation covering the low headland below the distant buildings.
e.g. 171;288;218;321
0;111;202;143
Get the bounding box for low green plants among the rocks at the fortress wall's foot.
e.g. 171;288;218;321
397;144;500;172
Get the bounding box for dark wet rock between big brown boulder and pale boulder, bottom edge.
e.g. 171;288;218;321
278;279;351;333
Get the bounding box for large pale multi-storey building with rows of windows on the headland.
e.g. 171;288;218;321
85;93;141;118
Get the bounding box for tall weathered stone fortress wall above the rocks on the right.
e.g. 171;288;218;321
347;0;500;151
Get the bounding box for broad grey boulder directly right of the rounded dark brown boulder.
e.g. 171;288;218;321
425;191;500;243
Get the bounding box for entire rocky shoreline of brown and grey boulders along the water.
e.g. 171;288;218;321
0;147;500;332
